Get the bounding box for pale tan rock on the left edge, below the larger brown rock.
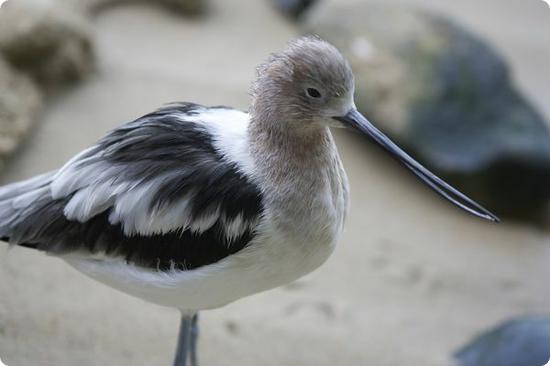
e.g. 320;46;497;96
0;58;42;166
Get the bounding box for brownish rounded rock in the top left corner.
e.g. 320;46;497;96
0;0;94;88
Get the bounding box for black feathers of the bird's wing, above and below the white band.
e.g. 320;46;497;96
5;103;262;270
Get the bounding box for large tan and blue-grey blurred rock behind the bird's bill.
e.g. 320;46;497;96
305;3;550;223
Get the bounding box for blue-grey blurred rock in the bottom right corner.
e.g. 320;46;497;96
455;317;550;366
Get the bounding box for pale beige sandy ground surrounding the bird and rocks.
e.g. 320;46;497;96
0;0;550;366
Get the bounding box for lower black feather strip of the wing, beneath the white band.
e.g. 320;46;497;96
7;197;253;270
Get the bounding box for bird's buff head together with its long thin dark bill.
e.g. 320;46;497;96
251;36;498;221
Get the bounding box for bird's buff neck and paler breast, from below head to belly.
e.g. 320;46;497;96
249;126;348;280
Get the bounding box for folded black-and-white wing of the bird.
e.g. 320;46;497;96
0;104;262;269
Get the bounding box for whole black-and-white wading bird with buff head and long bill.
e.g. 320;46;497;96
0;35;498;366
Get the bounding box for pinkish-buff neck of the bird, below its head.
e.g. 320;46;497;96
248;116;347;242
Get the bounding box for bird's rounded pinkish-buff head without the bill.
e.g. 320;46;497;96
252;36;355;132
